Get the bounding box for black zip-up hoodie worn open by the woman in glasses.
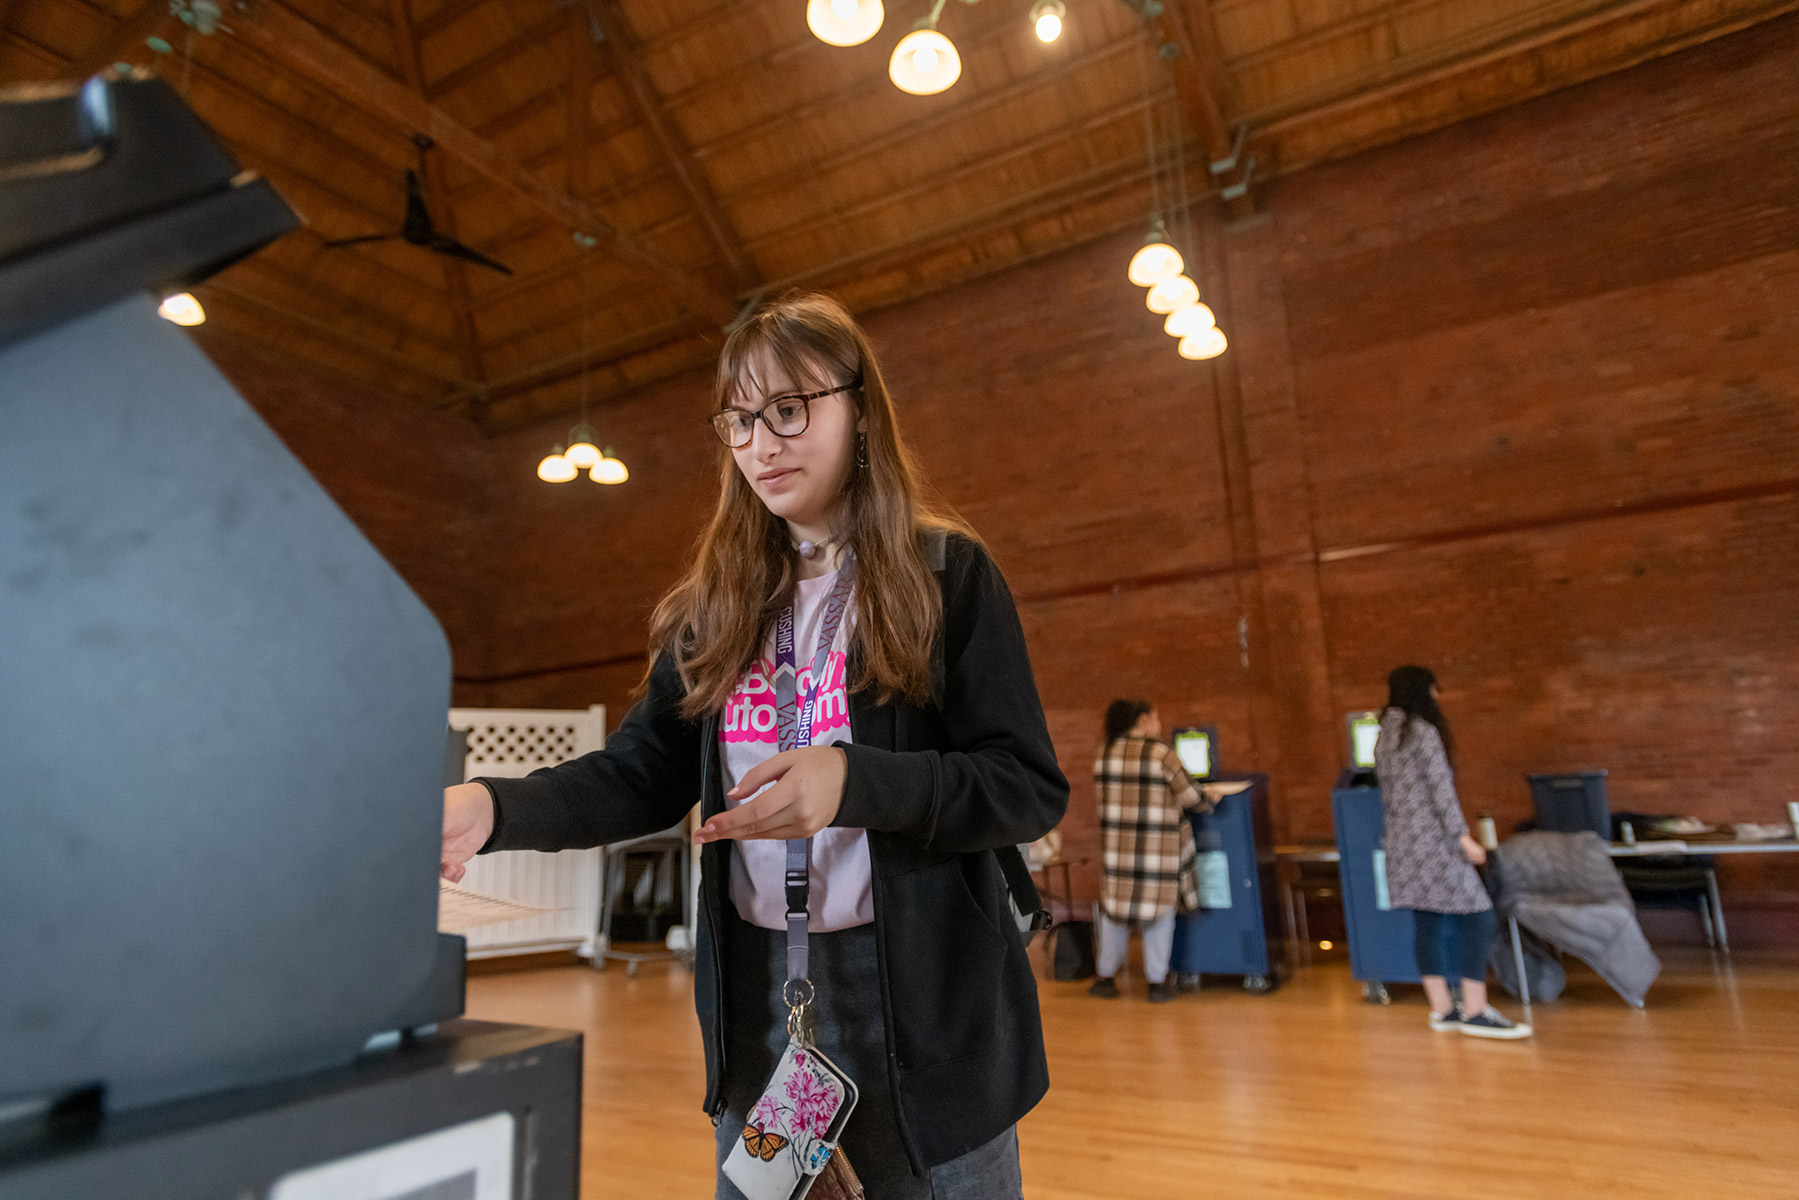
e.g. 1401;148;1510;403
482;534;1069;1175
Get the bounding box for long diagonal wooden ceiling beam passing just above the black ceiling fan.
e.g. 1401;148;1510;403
230;0;738;324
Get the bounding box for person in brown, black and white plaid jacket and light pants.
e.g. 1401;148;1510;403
1088;700;1211;1004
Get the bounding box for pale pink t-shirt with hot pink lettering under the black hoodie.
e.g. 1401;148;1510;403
718;574;874;934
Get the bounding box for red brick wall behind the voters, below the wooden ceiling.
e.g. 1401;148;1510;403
214;18;1799;921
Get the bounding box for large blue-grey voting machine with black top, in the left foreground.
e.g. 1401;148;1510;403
0;77;461;1110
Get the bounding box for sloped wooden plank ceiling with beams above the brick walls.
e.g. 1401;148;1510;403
0;0;1799;430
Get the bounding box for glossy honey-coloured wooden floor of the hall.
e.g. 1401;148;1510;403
468;952;1799;1200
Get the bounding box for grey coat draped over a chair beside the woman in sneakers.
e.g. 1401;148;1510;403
1495;831;1662;1007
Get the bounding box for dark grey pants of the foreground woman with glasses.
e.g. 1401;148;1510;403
716;910;1024;1200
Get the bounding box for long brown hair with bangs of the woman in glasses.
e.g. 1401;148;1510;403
644;293;973;720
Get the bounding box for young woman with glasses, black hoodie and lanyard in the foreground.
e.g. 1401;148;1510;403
443;295;1069;1200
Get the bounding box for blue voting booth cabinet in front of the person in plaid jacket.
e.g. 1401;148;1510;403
1173;774;1284;993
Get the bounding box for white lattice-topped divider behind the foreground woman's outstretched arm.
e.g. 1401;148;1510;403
450;703;606;959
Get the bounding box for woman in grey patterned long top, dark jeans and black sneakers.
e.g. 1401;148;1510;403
1374;667;1531;1038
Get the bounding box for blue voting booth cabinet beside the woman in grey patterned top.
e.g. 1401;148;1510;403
1331;788;1418;1004
